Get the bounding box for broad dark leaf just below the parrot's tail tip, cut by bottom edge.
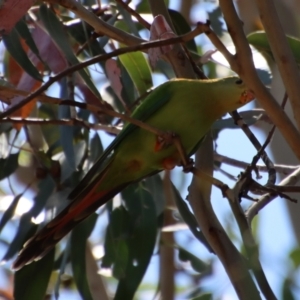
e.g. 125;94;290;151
14;249;55;300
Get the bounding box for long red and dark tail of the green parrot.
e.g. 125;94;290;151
12;183;129;270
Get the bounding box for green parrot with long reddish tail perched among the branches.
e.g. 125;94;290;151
13;77;254;269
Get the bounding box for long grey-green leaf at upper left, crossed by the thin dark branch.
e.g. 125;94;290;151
40;4;101;98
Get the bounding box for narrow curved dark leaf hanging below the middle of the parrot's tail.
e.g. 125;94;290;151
70;214;98;300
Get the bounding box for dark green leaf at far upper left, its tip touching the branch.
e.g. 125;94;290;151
2;28;43;81
